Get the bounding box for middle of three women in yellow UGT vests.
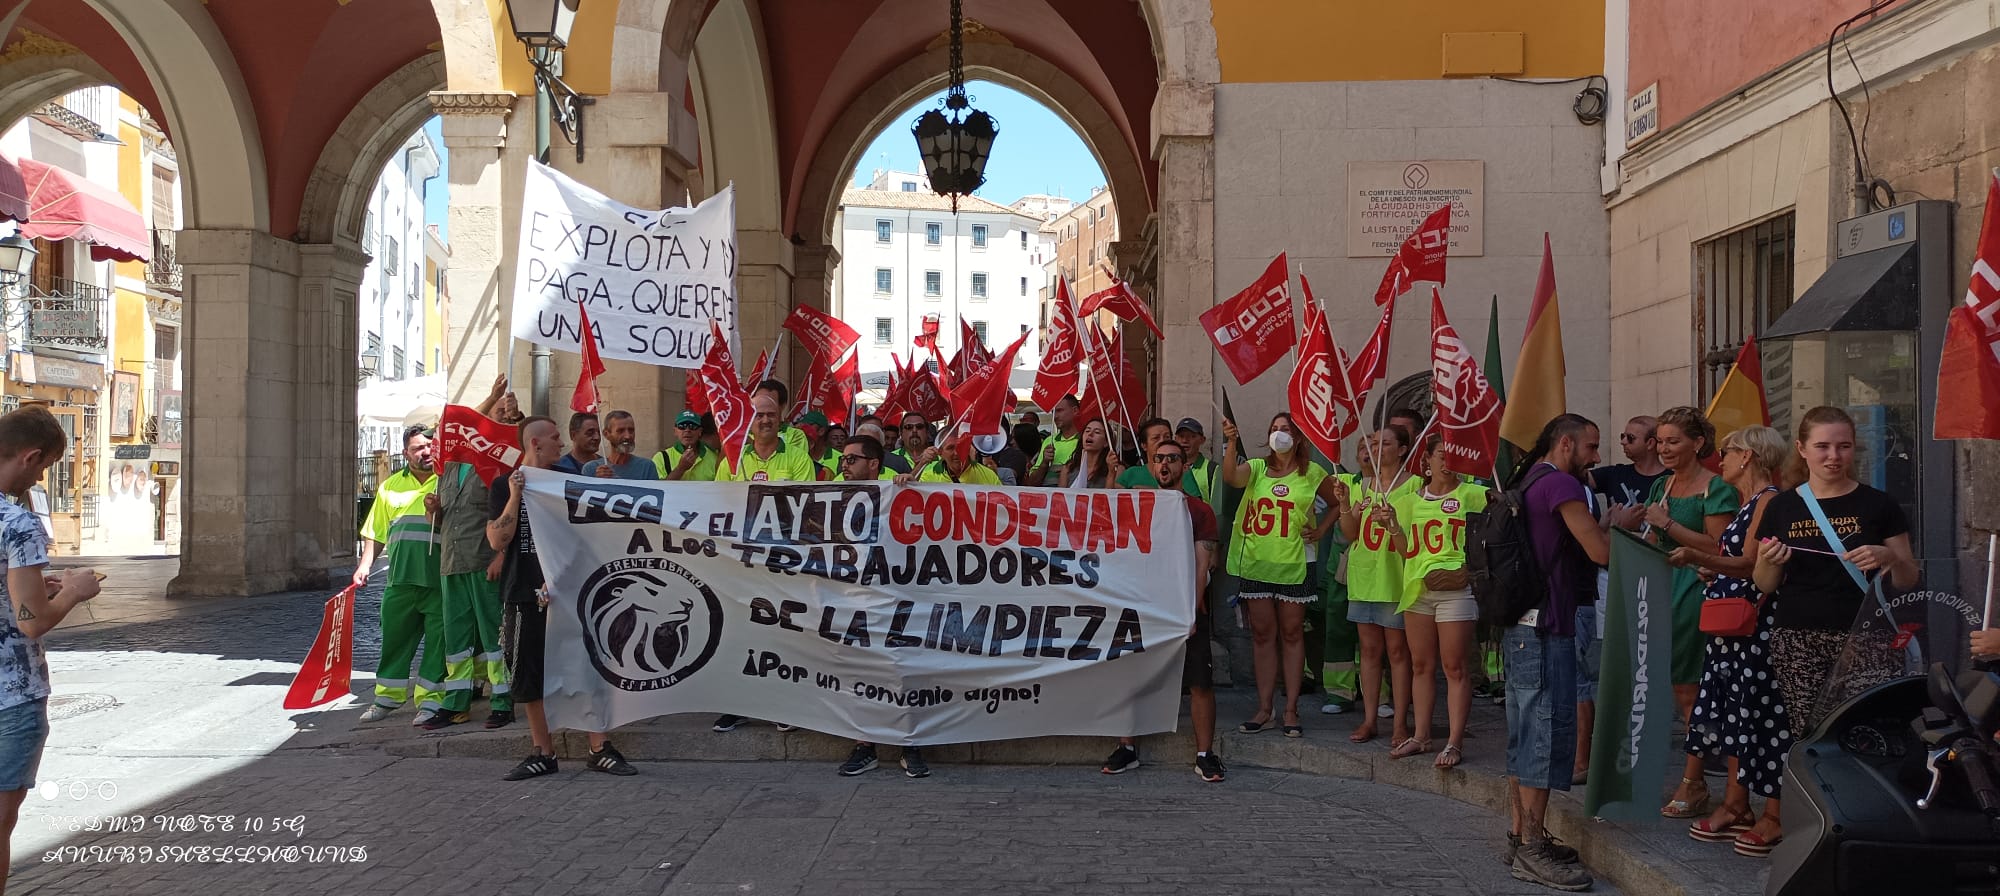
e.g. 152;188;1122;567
1340;426;1418;748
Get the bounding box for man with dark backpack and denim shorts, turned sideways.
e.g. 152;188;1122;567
1466;414;1610;890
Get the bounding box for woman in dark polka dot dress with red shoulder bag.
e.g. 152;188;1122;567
1670;426;1792;854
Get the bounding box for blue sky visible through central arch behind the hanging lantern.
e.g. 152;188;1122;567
854;80;1104;206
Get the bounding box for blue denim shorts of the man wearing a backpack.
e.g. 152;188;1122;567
1502;626;1576;790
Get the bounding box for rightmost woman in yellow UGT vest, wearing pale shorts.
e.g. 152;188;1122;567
1374;432;1486;768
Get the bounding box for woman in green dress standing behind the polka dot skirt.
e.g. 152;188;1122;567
1646;406;1742;818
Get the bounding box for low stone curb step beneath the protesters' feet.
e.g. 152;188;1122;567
368;716;1720;896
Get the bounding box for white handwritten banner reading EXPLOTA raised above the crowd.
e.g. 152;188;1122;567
514;160;736;368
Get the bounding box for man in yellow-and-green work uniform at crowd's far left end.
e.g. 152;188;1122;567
354;426;444;726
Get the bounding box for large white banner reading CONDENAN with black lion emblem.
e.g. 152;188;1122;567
526;470;1194;744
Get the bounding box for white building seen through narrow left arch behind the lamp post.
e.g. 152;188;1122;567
356;128;444;458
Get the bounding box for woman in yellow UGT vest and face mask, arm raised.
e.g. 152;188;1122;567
1222;414;1344;738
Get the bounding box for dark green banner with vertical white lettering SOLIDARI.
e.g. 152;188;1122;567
1584;528;1678;822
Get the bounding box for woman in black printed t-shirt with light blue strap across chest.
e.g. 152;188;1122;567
1754;406;1918;738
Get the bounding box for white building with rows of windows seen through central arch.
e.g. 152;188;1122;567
834;186;1050;382
